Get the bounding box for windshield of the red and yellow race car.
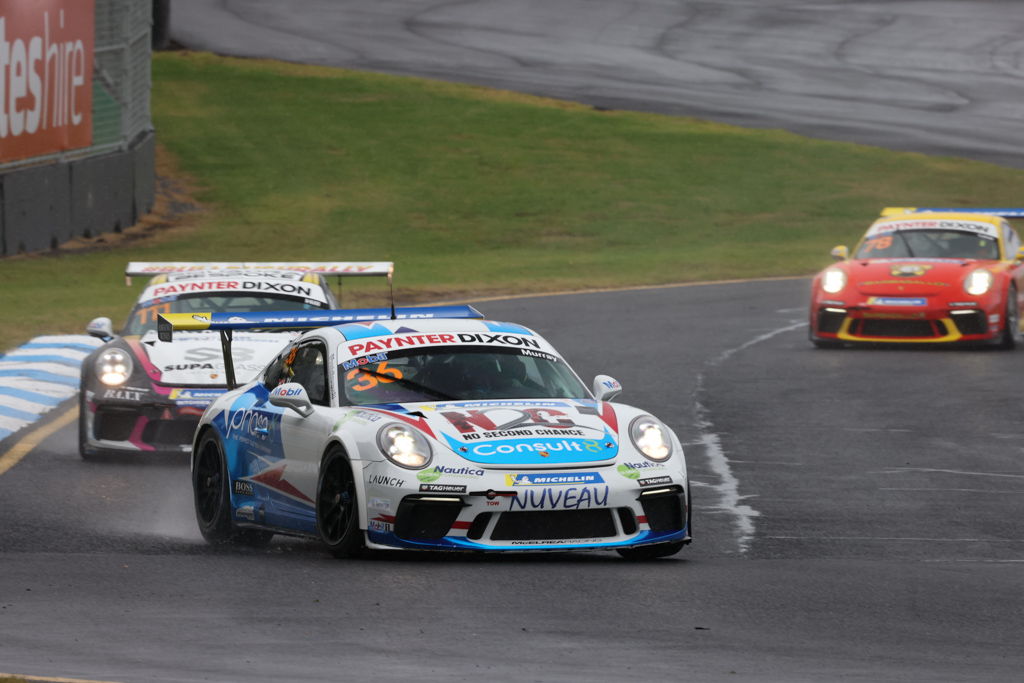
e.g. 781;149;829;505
854;230;999;260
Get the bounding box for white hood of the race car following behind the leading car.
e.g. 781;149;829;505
126;332;295;386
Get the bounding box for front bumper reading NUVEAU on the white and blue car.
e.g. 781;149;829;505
366;465;690;551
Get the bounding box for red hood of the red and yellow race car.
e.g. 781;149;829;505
848;258;998;297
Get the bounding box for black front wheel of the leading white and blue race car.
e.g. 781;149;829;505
316;445;366;558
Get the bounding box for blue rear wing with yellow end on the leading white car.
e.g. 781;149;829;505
157;305;483;390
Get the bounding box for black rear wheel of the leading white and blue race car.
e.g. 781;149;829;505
193;431;273;548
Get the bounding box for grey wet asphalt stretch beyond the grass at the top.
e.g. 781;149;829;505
172;0;1024;167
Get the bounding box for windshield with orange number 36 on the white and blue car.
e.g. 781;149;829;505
338;346;591;405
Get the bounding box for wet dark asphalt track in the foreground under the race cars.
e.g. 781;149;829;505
6;280;1024;683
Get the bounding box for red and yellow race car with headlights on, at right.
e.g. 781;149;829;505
810;207;1024;349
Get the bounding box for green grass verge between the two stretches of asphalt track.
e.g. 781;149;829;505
0;52;1024;349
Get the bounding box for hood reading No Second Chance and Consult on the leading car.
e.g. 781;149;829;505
374;399;618;468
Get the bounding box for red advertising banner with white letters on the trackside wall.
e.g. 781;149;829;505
0;0;94;163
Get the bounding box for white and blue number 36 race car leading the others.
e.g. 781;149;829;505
159;306;690;559
